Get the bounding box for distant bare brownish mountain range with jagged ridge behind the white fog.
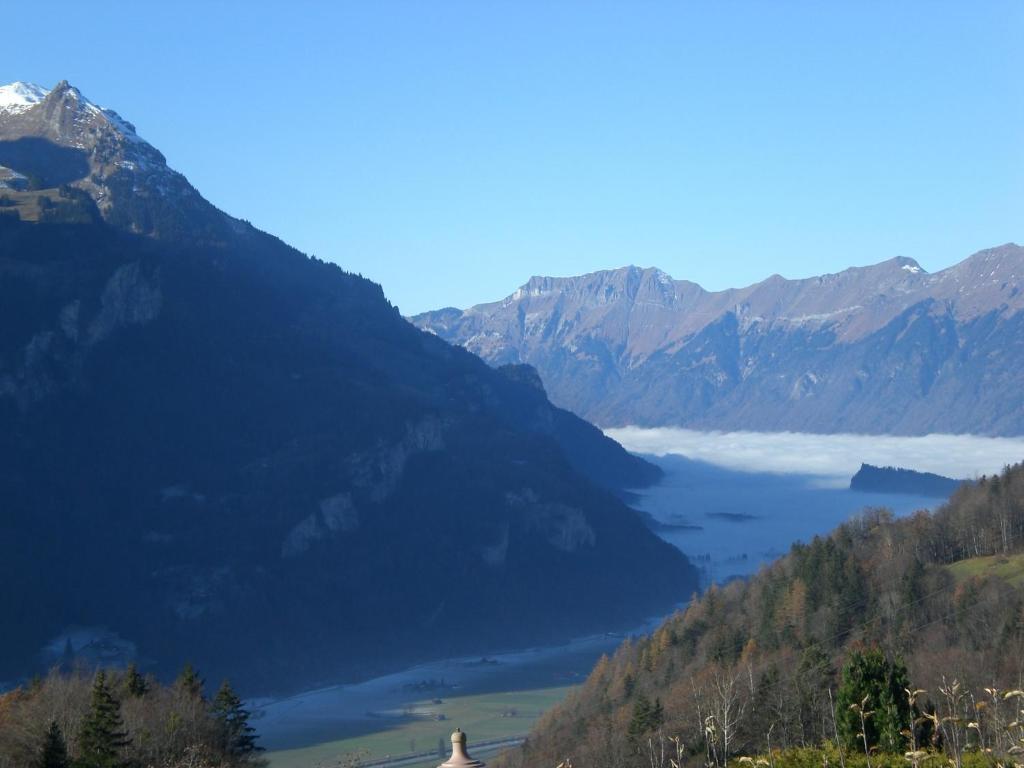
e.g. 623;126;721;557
412;249;1024;435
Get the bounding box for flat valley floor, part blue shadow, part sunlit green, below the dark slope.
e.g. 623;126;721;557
256;616;663;766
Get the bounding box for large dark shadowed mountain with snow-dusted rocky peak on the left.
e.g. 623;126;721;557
0;83;696;691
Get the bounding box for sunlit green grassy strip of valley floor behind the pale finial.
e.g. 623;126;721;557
265;687;571;768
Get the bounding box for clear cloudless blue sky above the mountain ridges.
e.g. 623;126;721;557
0;0;1024;313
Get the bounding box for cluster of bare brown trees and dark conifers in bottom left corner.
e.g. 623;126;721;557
0;665;265;768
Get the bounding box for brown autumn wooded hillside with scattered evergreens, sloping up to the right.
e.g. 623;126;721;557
497;465;1024;768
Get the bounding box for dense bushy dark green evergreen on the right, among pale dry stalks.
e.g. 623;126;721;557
836;648;911;754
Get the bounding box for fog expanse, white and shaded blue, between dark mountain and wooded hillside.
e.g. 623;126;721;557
606;427;1024;583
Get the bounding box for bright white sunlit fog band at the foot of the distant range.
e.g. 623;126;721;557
605;427;1024;484
